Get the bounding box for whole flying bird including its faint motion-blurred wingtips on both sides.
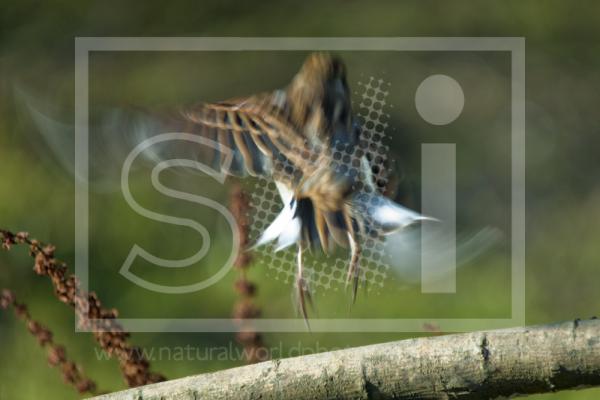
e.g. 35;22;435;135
17;53;497;320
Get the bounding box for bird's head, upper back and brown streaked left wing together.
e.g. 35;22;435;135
172;53;358;186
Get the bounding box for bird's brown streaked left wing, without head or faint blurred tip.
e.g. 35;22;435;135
172;91;314;179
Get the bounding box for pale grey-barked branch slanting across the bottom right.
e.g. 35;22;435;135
92;319;600;400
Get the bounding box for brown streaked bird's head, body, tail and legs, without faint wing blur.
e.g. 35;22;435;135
164;53;429;319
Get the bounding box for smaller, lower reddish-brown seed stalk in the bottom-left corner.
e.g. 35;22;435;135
0;289;96;394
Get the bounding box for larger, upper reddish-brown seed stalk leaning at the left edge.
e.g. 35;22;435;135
0;229;165;387
